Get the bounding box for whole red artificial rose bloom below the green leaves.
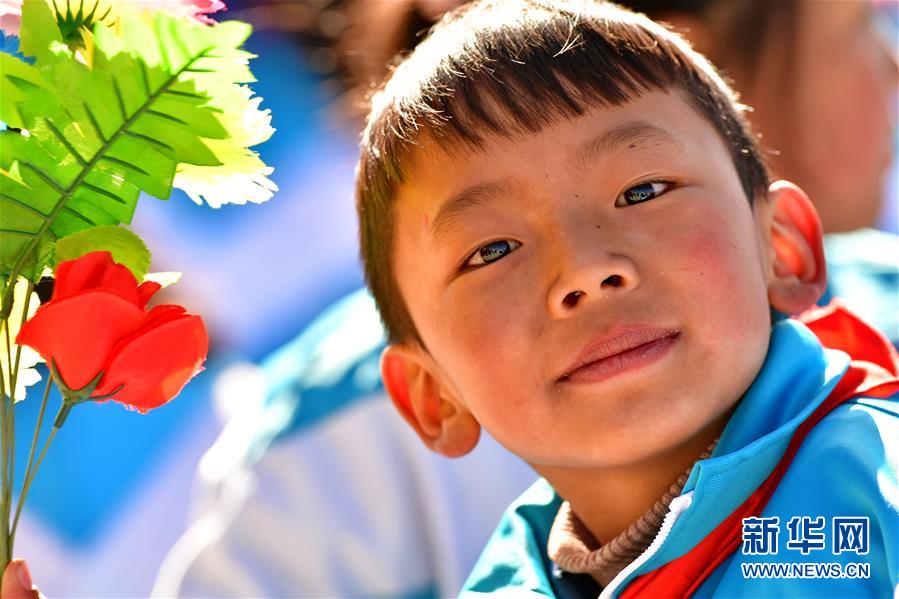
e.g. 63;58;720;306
16;252;209;412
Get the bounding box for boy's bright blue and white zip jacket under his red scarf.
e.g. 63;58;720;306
462;308;899;598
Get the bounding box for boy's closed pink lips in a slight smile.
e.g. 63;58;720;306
556;326;681;383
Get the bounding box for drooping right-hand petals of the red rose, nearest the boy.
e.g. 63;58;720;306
94;314;209;412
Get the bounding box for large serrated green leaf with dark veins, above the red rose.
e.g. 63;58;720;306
0;8;264;286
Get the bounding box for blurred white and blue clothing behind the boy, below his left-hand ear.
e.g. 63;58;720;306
153;290;536;598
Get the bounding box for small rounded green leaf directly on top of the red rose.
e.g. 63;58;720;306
56;225;150;281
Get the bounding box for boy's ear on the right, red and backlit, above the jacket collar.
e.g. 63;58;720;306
765;181;827;314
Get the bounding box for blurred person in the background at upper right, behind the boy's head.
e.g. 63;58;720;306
621;0;899;344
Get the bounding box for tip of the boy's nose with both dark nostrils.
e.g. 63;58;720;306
548;254;640;318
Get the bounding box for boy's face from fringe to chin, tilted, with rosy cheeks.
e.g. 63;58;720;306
392;91;812;467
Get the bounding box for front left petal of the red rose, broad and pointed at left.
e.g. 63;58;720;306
16;290;143;389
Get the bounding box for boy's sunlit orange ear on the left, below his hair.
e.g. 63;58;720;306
381;344;481;458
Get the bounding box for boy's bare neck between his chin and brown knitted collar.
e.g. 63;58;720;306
532;402;739;545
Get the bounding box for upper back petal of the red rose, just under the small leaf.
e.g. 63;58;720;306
53;252;146;307
